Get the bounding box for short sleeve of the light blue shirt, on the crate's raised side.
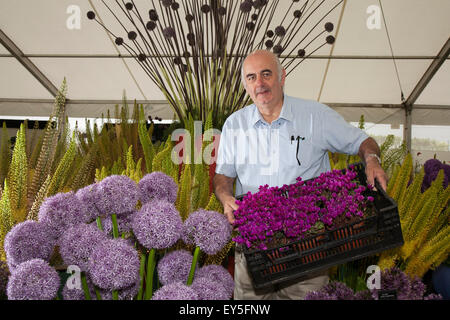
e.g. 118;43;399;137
321;107;369;155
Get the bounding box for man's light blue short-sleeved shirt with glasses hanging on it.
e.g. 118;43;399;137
216;95;368;196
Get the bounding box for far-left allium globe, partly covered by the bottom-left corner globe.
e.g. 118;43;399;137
4;220;56;271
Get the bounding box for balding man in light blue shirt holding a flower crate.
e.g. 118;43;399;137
213;50;387;299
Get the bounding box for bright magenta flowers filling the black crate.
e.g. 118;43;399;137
233;169;374;250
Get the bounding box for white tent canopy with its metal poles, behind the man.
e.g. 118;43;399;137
0;0;450;162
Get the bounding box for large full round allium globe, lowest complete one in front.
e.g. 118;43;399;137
88;238;140;290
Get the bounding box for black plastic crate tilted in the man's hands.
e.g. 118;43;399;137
237;163;403;289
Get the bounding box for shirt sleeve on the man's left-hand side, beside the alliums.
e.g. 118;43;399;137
216;119;237;178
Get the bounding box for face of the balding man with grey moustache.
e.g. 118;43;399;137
244;53;286;107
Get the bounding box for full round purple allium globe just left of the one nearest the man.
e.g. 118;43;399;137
132;200;183;249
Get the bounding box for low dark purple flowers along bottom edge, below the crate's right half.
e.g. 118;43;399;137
305;267;442;300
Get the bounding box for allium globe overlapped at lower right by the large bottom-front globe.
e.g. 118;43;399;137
58;223;107;271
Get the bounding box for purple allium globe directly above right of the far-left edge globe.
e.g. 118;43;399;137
38;191;86;239
